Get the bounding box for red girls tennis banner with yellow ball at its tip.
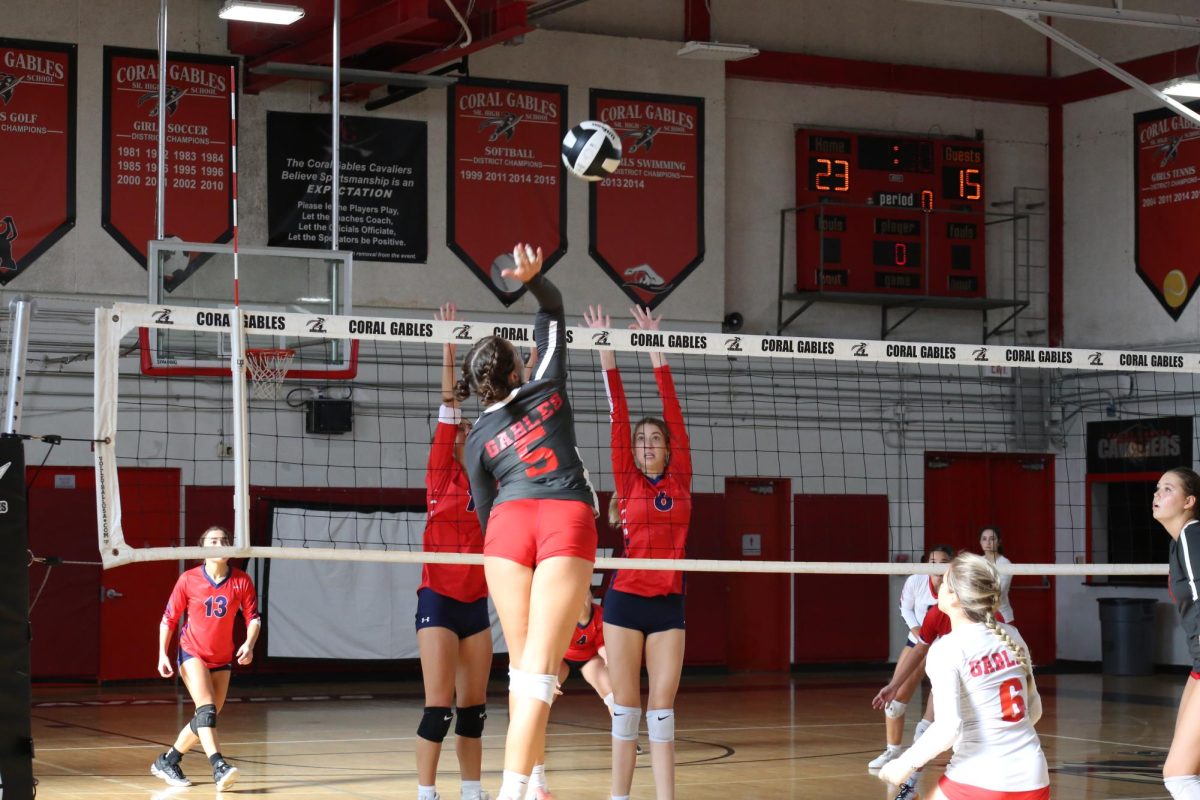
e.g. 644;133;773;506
1133;103;1200;320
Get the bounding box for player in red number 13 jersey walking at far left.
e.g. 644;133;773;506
150;525;260;789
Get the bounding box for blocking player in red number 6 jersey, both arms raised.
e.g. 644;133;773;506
583;306;691;800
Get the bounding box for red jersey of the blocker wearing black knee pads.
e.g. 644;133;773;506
420;405;487;603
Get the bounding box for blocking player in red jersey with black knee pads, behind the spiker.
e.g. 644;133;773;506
416;303;492;800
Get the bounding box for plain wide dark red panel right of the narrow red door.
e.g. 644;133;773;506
792;494;894;663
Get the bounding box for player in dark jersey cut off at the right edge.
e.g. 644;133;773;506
1153;467;1200;800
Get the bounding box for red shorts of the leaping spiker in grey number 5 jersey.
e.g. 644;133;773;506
484;499;596;567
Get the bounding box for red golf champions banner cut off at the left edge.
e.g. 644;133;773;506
0;38;77;285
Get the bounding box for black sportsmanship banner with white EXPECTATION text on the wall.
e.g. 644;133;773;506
266;112;430;263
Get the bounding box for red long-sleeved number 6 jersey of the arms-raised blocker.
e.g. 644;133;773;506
604;366;691;597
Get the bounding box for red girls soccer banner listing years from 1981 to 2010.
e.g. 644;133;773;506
101;47;238;275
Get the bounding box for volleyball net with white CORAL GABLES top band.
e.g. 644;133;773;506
95;303;1200;576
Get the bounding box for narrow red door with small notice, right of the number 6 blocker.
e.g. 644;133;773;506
725;477;791;670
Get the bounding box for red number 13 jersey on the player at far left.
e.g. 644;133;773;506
162;564;258;667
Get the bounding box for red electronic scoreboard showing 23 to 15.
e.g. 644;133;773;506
796;130;988;297
